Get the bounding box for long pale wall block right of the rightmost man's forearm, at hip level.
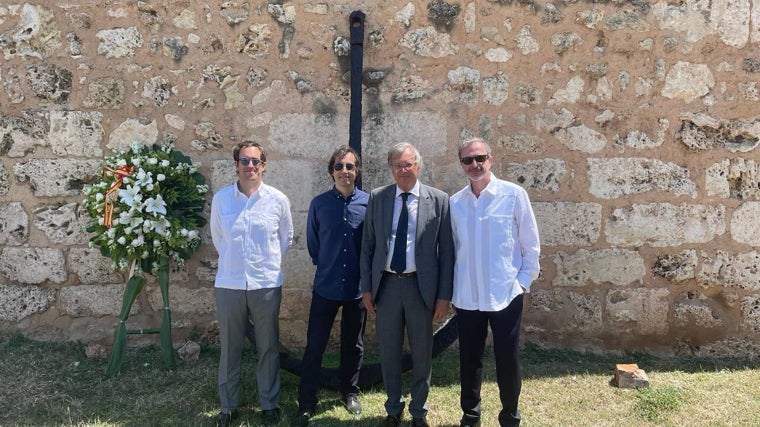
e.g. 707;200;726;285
552;248;646;286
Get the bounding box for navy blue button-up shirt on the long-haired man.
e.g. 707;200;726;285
306;187;369;301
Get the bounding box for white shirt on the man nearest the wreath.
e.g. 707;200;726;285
211;183;293;290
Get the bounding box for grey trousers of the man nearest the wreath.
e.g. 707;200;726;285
214;287;282;413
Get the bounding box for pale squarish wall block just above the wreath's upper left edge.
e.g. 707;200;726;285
49;111;104;157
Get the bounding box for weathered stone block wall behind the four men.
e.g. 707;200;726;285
0;0;760;356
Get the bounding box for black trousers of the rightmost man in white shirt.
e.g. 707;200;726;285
457;295;523;427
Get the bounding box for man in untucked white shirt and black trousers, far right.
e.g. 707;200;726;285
450;139;540;427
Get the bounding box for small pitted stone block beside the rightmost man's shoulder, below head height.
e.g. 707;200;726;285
507;159;573;192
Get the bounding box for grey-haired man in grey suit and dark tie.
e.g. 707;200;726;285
360;142;454;427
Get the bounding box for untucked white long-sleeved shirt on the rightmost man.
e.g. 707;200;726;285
450;174;541;311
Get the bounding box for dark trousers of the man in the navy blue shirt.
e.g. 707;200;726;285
298;293;367;410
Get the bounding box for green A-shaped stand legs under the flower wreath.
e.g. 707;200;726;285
106;256;177;377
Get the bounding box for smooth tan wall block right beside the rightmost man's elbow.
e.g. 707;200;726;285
533;202;602;246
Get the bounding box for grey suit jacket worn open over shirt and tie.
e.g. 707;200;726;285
360;184;454;310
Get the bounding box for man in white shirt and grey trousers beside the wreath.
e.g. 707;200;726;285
210;141;293;426
